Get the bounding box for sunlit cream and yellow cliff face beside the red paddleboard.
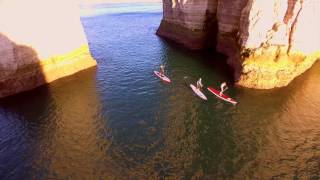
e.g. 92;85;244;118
236;0;320;89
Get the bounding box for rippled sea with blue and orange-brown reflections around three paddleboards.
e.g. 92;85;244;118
0;4;320;179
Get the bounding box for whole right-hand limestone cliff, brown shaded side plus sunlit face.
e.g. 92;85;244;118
158;0;320;89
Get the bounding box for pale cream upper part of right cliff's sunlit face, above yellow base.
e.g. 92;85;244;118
240;0;320;54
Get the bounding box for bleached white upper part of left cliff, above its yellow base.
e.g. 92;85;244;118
0;0;87;59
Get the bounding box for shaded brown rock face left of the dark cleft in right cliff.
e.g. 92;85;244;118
157;0;217;49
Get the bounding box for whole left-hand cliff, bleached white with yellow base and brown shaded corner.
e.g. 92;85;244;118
0;0;96;97
